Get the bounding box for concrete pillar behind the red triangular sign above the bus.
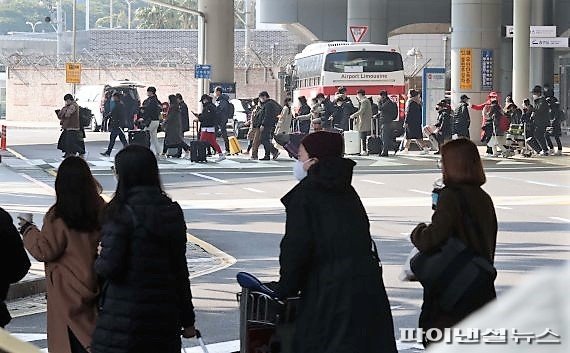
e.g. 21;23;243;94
346;0;388;44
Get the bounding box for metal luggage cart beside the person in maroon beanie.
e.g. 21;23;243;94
237;288;299;353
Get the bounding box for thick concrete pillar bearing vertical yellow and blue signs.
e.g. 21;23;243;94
450;0;500;141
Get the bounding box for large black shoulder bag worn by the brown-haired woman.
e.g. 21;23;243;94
410;192;497;312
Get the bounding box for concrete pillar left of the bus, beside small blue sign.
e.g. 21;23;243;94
198;0;234;87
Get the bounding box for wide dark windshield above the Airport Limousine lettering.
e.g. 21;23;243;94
325;51;404;73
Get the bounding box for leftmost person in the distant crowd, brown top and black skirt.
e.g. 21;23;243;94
57;93;85;158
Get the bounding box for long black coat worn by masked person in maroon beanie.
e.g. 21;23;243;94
278;158;396;353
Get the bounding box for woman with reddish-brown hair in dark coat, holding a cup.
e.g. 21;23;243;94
411;138;497;344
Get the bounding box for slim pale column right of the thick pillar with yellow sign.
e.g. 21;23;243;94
513;0;531;105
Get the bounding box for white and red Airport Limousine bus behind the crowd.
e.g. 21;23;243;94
292;42;405;119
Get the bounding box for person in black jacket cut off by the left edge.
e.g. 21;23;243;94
0;207;30;328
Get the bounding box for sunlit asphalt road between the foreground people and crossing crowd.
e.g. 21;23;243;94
0;131;570;350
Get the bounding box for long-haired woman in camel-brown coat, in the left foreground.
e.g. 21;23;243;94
20;157;104;353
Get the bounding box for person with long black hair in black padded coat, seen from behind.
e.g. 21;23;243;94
89;145;195;353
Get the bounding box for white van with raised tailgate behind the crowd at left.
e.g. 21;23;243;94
75;80;145;131
